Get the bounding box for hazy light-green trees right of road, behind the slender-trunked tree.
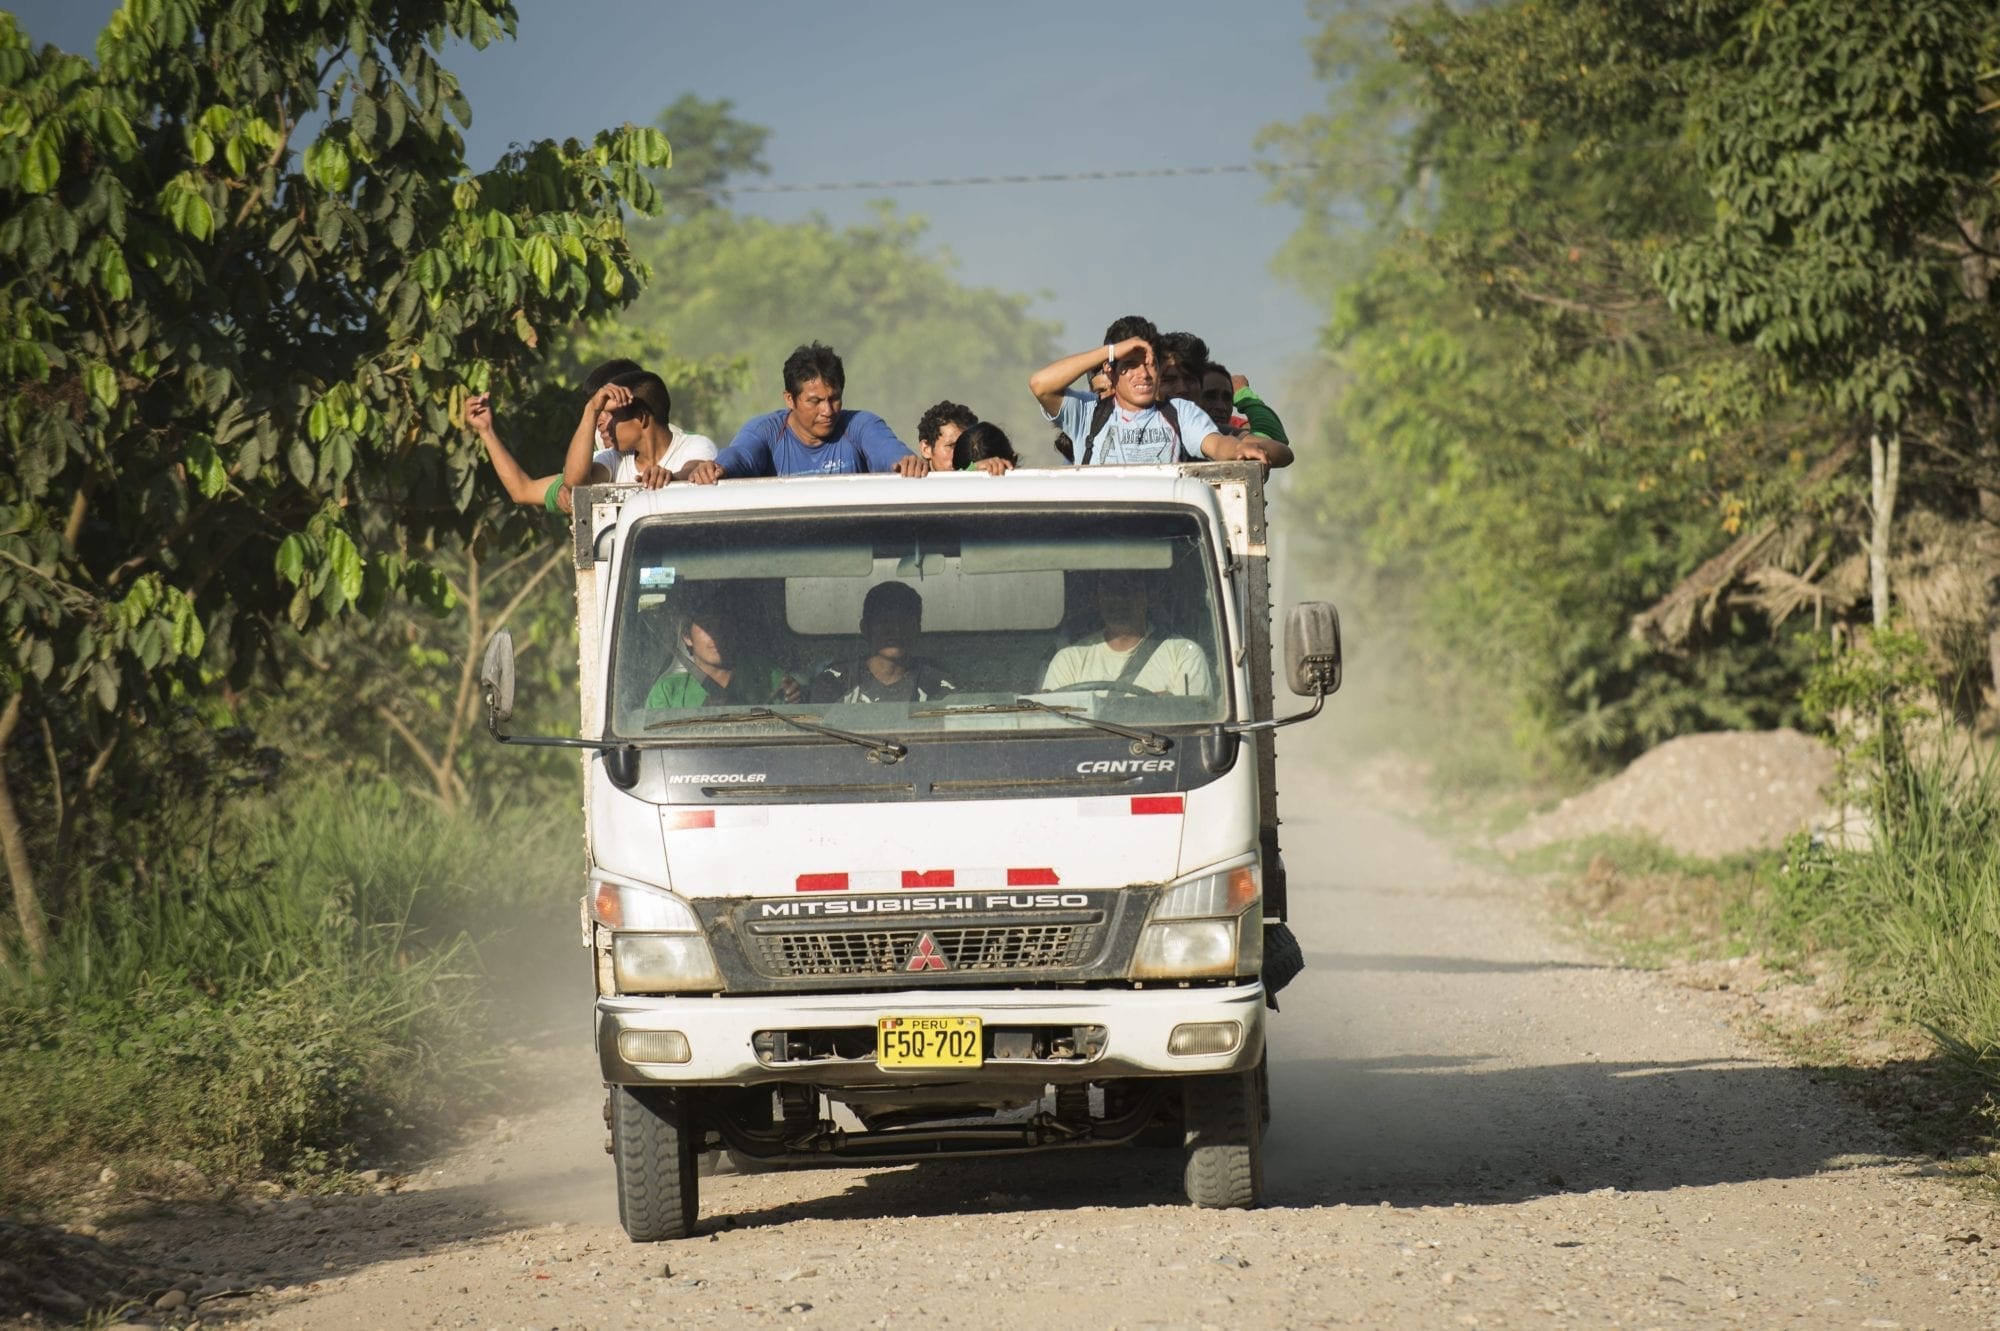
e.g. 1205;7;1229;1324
1264;4;1816;759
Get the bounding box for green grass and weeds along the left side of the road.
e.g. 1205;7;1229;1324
0;783;580;1211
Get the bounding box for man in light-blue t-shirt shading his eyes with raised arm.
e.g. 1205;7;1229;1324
1028;314;1292;468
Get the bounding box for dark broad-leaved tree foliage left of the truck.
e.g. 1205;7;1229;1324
0;0;668;955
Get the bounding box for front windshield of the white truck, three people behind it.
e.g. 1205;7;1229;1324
610;508;1230;743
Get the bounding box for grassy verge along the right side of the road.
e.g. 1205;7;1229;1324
1508;747;2000;1185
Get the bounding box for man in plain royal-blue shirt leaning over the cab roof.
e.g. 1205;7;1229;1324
676;342;930;486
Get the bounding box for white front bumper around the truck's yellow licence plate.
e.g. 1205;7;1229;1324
596;981;1264;1087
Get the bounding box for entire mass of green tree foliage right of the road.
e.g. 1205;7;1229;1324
1266;0;2000;755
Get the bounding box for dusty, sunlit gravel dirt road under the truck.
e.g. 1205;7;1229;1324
125;771;2000;1331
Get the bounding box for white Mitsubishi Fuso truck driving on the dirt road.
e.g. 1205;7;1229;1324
482;464;1340;1241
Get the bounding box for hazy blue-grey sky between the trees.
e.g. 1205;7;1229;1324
14;0;1324;382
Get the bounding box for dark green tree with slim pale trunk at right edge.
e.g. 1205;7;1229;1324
1658;0;2000;643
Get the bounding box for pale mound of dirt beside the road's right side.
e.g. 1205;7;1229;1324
1498;729;1834;857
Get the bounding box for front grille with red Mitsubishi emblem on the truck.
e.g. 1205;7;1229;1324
748;921;1104;979
